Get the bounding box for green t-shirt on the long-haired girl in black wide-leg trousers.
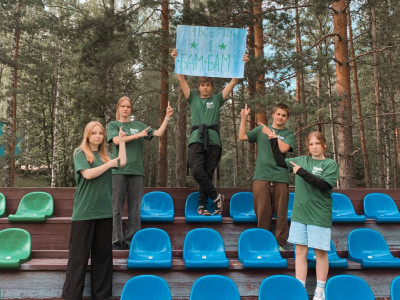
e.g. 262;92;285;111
72;148;113;221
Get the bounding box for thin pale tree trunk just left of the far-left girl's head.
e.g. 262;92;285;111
50;51;62;187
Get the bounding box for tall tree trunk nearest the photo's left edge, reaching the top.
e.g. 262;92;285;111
3;1;22;187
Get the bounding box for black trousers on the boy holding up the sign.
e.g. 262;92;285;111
189;143;221;205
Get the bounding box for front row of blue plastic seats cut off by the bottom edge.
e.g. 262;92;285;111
121;275;400;300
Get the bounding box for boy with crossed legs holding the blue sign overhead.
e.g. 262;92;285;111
171;49;248;216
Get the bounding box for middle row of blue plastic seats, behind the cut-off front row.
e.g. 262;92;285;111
127;228;400;269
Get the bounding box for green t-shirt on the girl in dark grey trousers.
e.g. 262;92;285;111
107;121;154;176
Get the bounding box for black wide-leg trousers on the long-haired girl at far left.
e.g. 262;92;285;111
62;218;113;300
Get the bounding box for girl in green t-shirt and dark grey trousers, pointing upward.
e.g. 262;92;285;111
107;96;174;250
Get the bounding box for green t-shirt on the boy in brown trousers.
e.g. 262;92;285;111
247;125;294;183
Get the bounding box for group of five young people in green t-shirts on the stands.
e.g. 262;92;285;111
62;49;338;300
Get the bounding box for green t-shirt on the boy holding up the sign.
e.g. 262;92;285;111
188;91;224;147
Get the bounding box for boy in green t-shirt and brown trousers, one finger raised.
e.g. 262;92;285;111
239;103;294;250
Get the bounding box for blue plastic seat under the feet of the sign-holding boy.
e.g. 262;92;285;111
185;192;222;223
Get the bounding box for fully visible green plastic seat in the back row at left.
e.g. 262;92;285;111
8;192;54;222
